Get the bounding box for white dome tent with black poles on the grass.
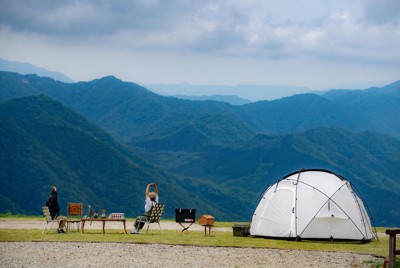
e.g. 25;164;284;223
250;169;376;241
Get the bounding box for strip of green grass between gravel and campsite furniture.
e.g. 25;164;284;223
0;217;400;267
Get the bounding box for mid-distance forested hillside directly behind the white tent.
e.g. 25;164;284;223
132;128;400;225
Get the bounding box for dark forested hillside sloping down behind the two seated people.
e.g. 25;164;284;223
0;95;216;217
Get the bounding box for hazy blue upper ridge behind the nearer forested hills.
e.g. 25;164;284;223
0;73;400;141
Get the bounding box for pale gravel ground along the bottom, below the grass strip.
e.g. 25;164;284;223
0;242;382;268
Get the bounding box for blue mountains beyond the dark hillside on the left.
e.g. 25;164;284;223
0;72;400;226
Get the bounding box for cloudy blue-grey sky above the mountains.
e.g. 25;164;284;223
0;0;400;90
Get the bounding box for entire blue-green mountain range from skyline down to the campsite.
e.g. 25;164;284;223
0;72;400;226
